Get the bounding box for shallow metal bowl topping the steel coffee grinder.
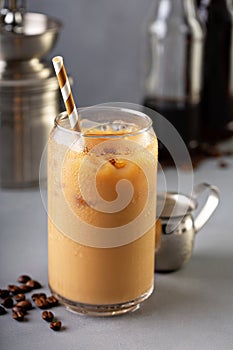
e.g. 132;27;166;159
0;0;62;62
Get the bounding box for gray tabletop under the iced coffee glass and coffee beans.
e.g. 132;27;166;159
0;159;233;350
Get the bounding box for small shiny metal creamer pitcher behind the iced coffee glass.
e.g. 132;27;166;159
155;183;220;272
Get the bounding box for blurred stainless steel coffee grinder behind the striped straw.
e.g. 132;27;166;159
0;0;61;188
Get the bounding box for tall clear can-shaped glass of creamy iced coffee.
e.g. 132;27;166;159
48;105;158;315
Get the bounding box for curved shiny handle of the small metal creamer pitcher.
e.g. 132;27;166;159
192;182;220;233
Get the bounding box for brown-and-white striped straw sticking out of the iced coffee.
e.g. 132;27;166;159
52;56;80;131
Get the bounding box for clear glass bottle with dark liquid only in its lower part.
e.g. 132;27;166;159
143;0;204;159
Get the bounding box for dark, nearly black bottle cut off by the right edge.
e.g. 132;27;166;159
198;0;233;142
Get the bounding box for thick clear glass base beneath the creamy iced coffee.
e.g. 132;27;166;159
50;287;154;316
